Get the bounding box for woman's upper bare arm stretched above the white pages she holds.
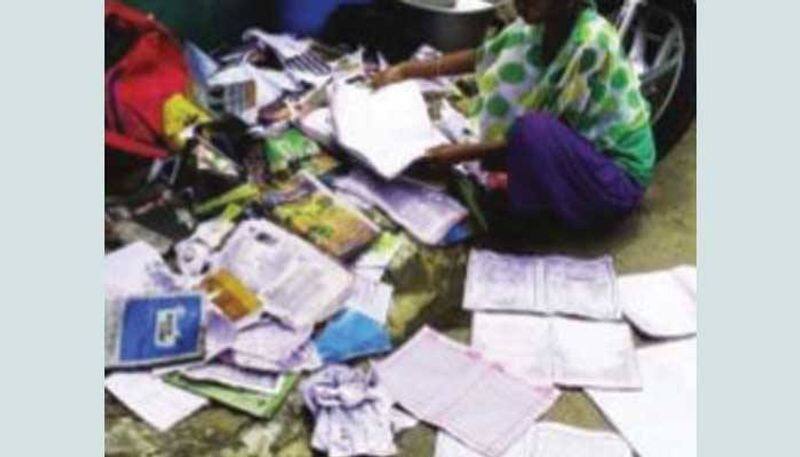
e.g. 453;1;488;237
372;49;476;87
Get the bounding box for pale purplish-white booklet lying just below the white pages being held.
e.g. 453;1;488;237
333;169;469;244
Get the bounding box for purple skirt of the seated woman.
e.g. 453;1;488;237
506;113;644;229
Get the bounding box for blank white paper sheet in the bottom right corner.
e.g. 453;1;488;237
587;338;697;457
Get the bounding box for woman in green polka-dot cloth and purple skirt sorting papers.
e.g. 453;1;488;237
373;0;655;229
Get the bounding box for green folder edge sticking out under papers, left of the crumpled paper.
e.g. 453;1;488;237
164;373;298;419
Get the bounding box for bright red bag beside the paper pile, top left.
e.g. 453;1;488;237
105;0;189;158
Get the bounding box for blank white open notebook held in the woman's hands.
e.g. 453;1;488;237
329;81;448;179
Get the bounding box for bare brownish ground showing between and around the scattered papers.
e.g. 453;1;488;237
105;124;696;457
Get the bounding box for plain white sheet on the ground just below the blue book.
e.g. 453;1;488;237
105;373;208;432
